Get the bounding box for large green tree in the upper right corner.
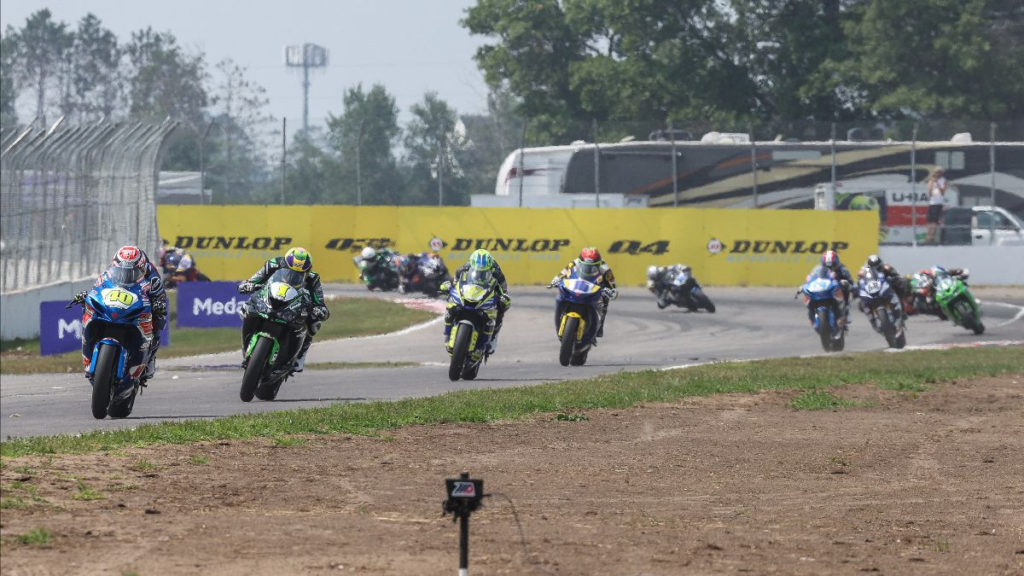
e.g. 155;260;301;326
834;0;1024;120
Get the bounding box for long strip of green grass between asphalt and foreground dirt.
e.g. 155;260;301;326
0;347;1024;457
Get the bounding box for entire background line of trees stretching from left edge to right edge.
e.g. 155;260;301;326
0;0;1024;205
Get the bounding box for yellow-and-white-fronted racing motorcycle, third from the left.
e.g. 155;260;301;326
440;270;498;381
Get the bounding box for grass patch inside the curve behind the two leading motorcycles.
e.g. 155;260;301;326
0;298;436;374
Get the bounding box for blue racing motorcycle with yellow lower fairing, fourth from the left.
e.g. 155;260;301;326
548;263;605;366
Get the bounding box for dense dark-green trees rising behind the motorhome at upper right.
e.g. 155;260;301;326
463;0;1024;141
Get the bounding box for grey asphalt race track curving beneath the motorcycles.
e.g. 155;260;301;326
0;285;1024;439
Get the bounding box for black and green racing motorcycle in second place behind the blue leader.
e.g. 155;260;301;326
239;268;309;402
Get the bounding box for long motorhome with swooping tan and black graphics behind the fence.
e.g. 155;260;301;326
472;132;1024;242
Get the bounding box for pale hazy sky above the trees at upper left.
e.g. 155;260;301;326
0;0;486;132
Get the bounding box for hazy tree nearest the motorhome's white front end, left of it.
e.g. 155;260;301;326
402;92;469;206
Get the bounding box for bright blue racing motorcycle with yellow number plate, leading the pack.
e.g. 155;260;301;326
67;266;154;419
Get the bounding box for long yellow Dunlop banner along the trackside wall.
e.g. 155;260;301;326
158;206;879;287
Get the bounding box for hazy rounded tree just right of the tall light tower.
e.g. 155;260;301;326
327;84;402;204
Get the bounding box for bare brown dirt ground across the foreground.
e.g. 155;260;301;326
0;374;1024;576
